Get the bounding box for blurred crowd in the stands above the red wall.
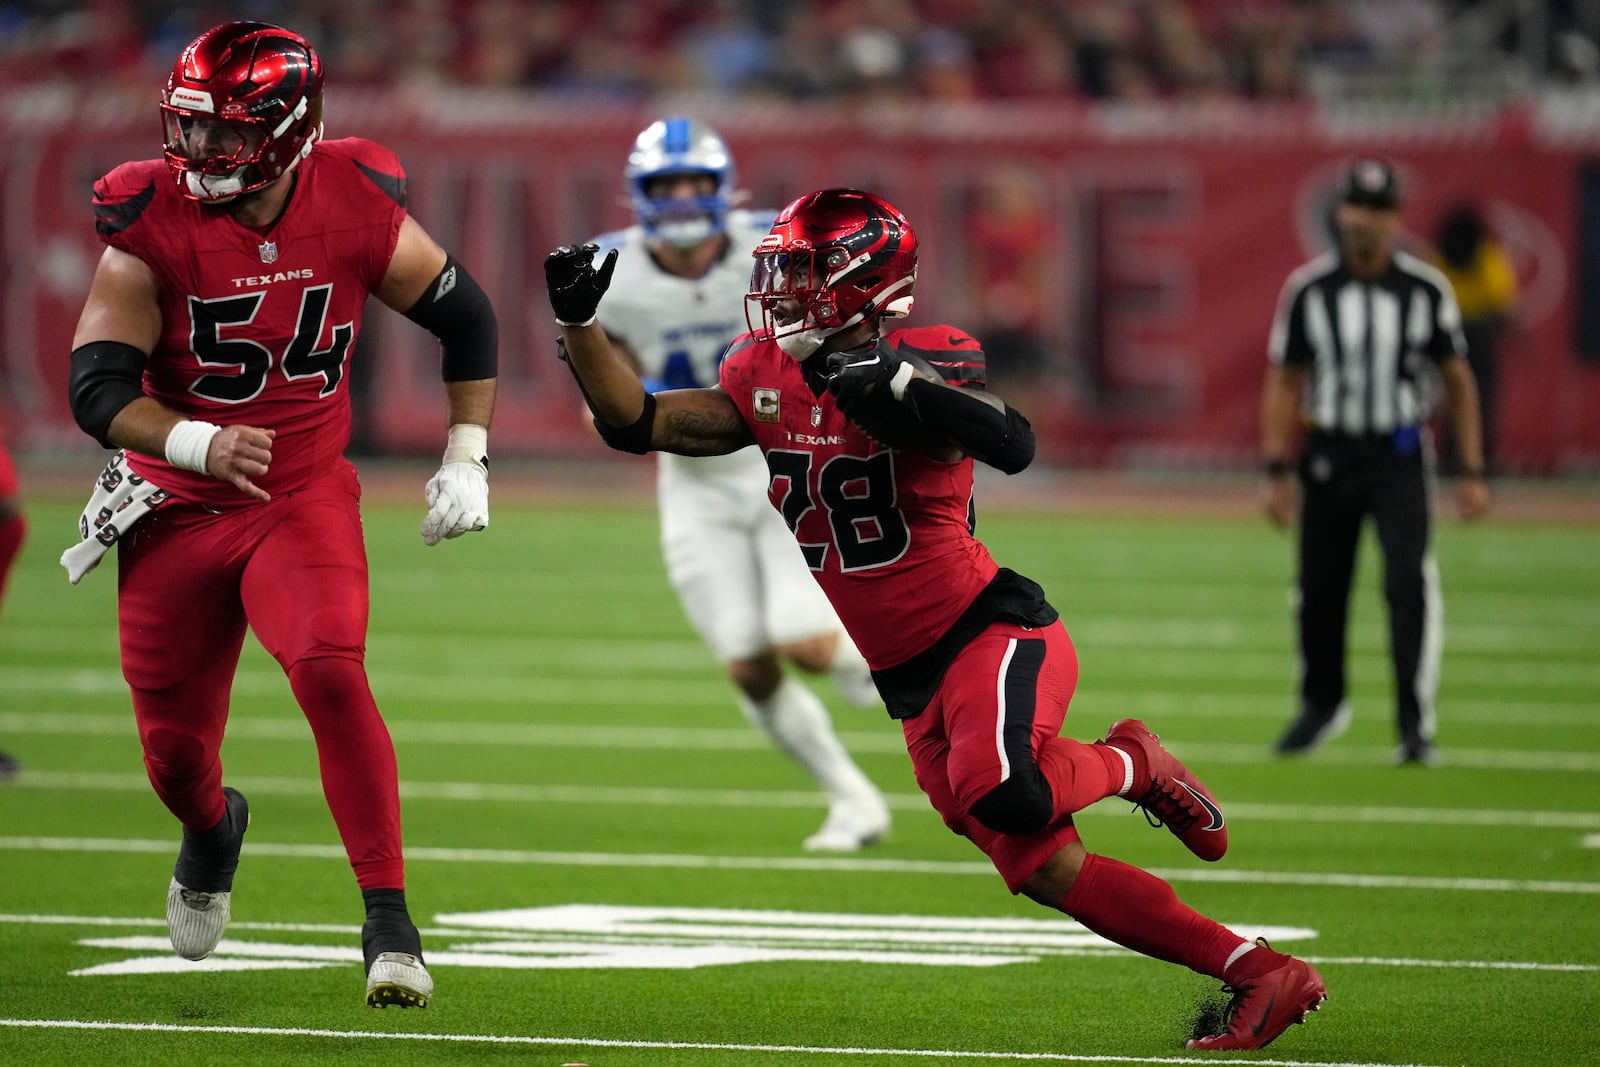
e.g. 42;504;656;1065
0;0;1600;101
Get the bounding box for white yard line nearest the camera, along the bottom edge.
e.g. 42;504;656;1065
0;1019;1465;1067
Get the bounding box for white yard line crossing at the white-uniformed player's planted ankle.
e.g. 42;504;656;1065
8;769;1600;831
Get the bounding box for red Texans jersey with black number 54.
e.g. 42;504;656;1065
94;138;406;506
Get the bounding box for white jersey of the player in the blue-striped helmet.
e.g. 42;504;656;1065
595;211;773;483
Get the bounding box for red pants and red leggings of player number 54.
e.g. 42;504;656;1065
117;461;405;889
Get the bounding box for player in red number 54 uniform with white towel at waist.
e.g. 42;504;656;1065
62;22;498;1006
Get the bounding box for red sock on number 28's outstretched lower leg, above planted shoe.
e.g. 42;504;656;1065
1058;853;1259;979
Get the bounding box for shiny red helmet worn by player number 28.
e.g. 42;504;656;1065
744;189;917;360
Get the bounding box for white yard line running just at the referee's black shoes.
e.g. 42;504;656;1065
0;713;1600;774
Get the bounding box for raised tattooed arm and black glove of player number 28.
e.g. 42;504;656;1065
544;245;755;456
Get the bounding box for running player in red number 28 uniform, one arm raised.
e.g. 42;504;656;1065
546;189;1326;1048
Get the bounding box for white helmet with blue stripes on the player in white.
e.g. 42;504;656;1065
622;117;733;245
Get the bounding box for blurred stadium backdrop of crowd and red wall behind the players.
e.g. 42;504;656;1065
9;0;1600;475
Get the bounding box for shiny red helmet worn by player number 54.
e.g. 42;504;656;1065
162;22;322;203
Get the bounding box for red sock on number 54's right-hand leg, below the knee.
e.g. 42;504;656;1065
288;656;405;889
